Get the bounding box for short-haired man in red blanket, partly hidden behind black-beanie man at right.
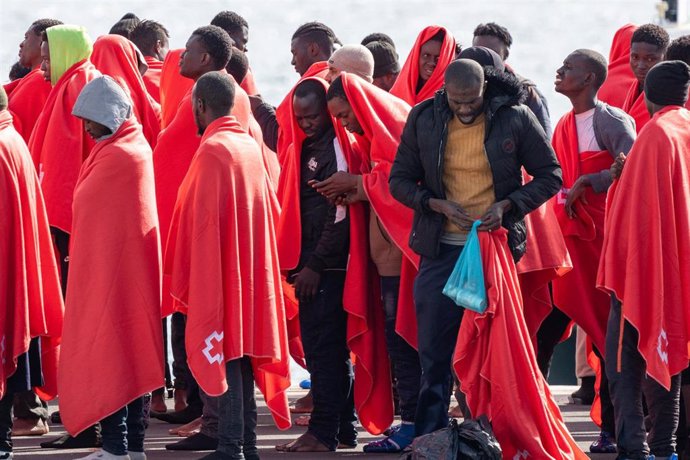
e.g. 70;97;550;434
621;24;670;133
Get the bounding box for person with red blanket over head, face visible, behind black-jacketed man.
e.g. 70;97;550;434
390;26;455;106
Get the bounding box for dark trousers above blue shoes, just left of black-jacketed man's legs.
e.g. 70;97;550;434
381;276;422;422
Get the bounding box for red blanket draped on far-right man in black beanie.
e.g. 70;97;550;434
597;106;690;389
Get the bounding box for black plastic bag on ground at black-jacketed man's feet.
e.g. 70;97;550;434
401;416;503;460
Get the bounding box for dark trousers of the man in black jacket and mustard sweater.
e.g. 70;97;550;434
414;244;464;436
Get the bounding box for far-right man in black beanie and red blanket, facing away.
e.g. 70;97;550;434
597;61;690;459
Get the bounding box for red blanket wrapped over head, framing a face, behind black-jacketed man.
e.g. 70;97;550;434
391;26;455;106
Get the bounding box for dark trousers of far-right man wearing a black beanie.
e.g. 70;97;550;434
606;296;681;459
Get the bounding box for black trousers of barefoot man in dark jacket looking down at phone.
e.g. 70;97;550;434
299;271;357;450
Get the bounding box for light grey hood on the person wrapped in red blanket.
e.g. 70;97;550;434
72;75;132;142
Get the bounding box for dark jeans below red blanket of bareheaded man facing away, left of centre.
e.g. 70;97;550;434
217;357;259;460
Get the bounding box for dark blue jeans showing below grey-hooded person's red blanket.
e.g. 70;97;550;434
101;396;146;455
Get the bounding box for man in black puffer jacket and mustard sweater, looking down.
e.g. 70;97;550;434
390;59;562;436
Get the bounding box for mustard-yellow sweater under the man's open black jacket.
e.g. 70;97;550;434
443;114;496;233
